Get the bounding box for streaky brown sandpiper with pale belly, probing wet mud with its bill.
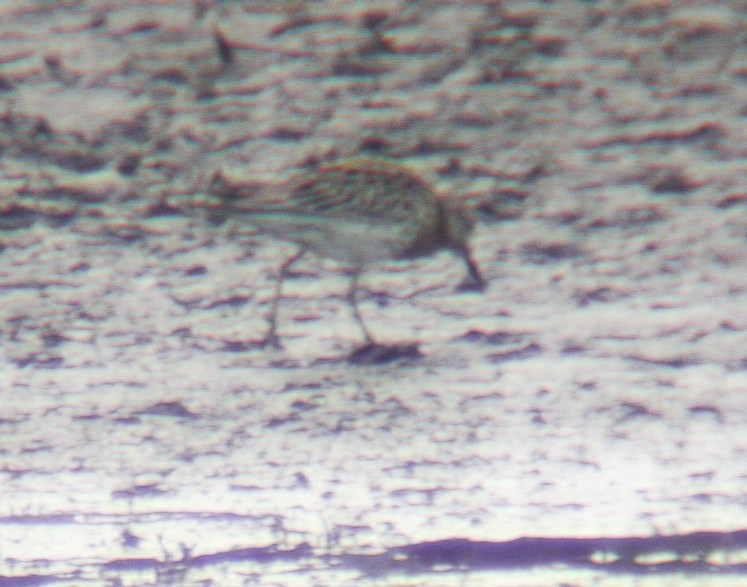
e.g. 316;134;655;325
212;159;485;356
